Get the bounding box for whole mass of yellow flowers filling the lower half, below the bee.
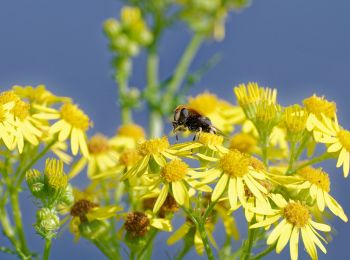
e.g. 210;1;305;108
0;83;350;259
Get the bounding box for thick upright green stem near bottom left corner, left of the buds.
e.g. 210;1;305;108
10;189;29;253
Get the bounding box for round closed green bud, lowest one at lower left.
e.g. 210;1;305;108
34;208;60;238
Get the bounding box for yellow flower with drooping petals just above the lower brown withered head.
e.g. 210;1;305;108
149;159;212;213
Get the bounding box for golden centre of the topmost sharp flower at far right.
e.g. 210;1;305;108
303;95;337;118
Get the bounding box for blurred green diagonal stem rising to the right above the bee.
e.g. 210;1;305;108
162;33;204;109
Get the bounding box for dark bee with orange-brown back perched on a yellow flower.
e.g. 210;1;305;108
172;105;220;140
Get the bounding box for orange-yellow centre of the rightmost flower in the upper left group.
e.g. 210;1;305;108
60;103;90;131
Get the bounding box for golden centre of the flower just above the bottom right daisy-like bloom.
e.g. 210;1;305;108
297;167;331;192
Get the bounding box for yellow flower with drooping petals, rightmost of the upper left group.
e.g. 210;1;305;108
35;103;91;157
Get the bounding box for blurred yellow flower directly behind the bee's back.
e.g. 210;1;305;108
188;92;244;133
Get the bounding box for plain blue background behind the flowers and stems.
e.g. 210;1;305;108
0;0;350;259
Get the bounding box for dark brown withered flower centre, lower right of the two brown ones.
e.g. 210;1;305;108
124;211;150;238
